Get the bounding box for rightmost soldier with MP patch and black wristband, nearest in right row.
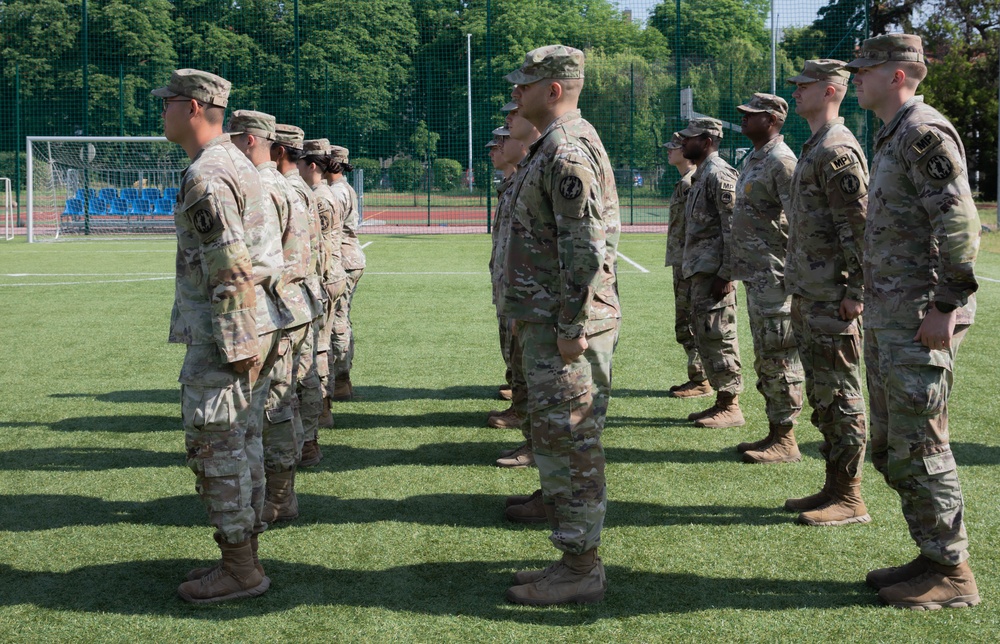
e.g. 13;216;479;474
848;34;980;609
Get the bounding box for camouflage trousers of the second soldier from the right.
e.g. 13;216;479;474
792;295;867;478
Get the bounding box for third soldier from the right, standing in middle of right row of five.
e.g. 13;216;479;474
732;93;805;463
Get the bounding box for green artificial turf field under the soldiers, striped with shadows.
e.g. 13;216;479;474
0;234;1000;642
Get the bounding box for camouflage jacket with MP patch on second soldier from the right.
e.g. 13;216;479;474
785;118;868;302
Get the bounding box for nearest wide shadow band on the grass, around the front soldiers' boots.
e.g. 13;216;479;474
0;556;876;626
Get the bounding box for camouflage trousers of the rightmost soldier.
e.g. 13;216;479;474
865;326;969;566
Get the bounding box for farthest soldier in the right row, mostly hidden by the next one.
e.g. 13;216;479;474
663;132;712;398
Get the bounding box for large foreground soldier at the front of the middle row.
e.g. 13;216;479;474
500;45;621;605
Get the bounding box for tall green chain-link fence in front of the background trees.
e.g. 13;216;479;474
0;0;908;230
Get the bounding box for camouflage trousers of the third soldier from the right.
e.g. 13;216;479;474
743;282;805;427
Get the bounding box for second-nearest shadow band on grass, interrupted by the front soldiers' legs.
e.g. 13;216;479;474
0;494;790;532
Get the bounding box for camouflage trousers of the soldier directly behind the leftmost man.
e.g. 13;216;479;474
263;324;311;472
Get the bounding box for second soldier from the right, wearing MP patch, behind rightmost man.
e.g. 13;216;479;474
785;59;871;526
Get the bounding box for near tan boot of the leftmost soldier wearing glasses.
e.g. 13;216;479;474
177;539;271;604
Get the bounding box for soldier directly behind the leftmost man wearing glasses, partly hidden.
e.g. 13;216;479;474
229;110;313;523
